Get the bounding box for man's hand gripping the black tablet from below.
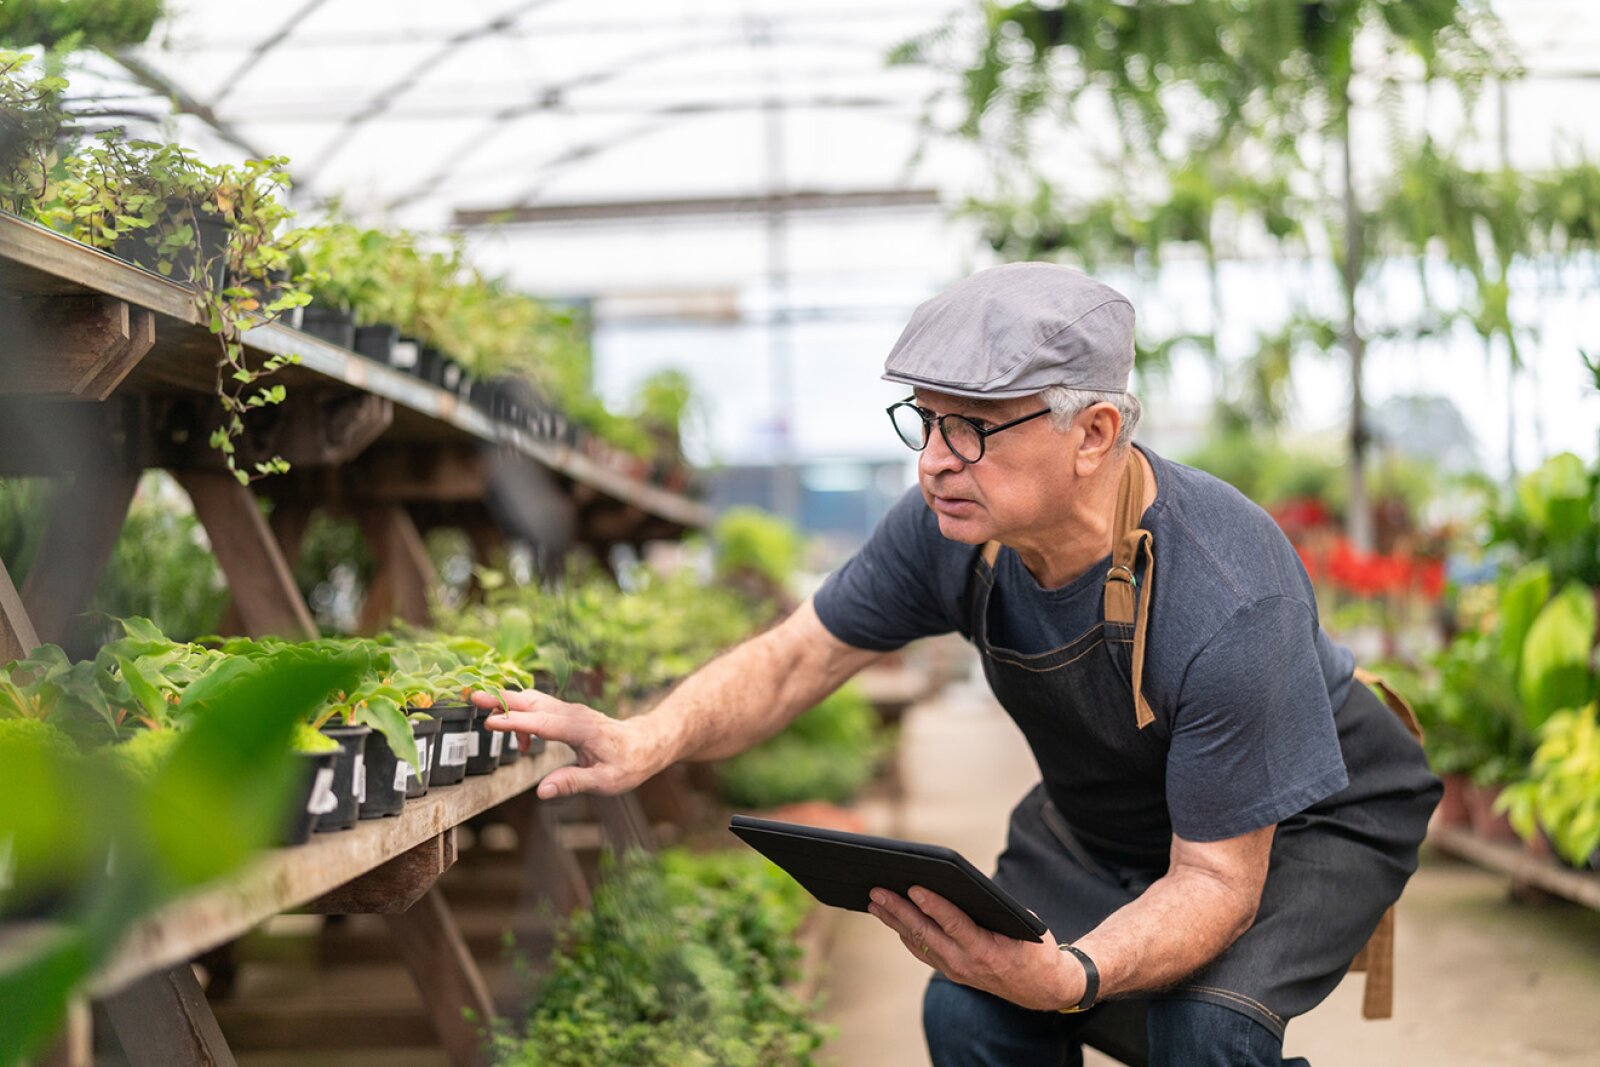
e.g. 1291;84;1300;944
867;886;1083;1011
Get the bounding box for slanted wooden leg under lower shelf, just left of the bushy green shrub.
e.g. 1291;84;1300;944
384;886;494;1067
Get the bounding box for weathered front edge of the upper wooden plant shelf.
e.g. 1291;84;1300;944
0;211;710;528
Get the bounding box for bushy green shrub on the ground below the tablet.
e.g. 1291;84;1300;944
493;854;822;1067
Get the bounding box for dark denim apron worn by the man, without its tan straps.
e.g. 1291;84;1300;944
966;470;1438;1037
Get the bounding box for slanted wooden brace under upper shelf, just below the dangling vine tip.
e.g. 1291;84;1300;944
173;470;317;638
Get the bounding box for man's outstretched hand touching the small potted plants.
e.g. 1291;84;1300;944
472;689;664;800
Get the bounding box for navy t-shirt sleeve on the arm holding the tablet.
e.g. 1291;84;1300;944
1166;597;1349;841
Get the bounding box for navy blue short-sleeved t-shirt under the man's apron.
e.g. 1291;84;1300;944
814;446;1355;841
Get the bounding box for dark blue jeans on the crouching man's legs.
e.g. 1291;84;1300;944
922;976;1310;1067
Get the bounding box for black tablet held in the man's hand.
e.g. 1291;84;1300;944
728;816;1046;941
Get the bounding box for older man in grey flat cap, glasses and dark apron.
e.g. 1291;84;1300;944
482;264;1438;1067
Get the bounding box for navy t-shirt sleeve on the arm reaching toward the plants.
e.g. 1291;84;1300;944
813;490;963;653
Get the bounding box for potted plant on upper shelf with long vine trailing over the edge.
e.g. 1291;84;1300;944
40;131;310;485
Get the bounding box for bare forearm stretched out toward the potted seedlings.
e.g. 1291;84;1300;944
642;600;877;769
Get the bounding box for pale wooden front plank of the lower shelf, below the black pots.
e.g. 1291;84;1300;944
91;744;573;993
